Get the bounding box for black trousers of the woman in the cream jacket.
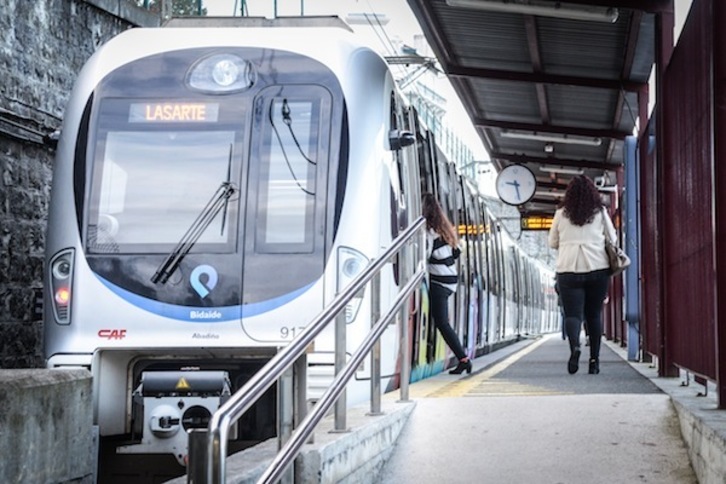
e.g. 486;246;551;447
557;269;610;359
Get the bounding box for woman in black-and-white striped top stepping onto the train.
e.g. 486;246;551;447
422;193;471;375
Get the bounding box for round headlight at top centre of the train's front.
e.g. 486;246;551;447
187;54;257;94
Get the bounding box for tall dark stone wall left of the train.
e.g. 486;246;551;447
0;0;159;368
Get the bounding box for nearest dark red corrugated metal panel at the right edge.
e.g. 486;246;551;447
663;2;723;379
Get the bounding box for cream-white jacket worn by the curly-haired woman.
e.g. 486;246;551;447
549;208;617;273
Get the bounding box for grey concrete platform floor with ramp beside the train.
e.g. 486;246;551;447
379;335;704;484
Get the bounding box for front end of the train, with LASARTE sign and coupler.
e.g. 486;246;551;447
45;20;356;474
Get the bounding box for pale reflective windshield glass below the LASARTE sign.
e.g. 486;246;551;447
87;130;236;253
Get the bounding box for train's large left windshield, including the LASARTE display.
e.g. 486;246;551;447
87;100;240;253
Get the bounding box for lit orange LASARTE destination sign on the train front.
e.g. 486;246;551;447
129;102;219;123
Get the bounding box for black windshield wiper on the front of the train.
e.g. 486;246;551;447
151;146;237;284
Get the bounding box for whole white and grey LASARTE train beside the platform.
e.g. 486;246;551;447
44;17;559;482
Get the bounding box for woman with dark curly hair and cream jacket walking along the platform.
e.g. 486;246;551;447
549;175;616;374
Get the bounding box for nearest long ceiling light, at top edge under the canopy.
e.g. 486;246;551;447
446;0;618;23
